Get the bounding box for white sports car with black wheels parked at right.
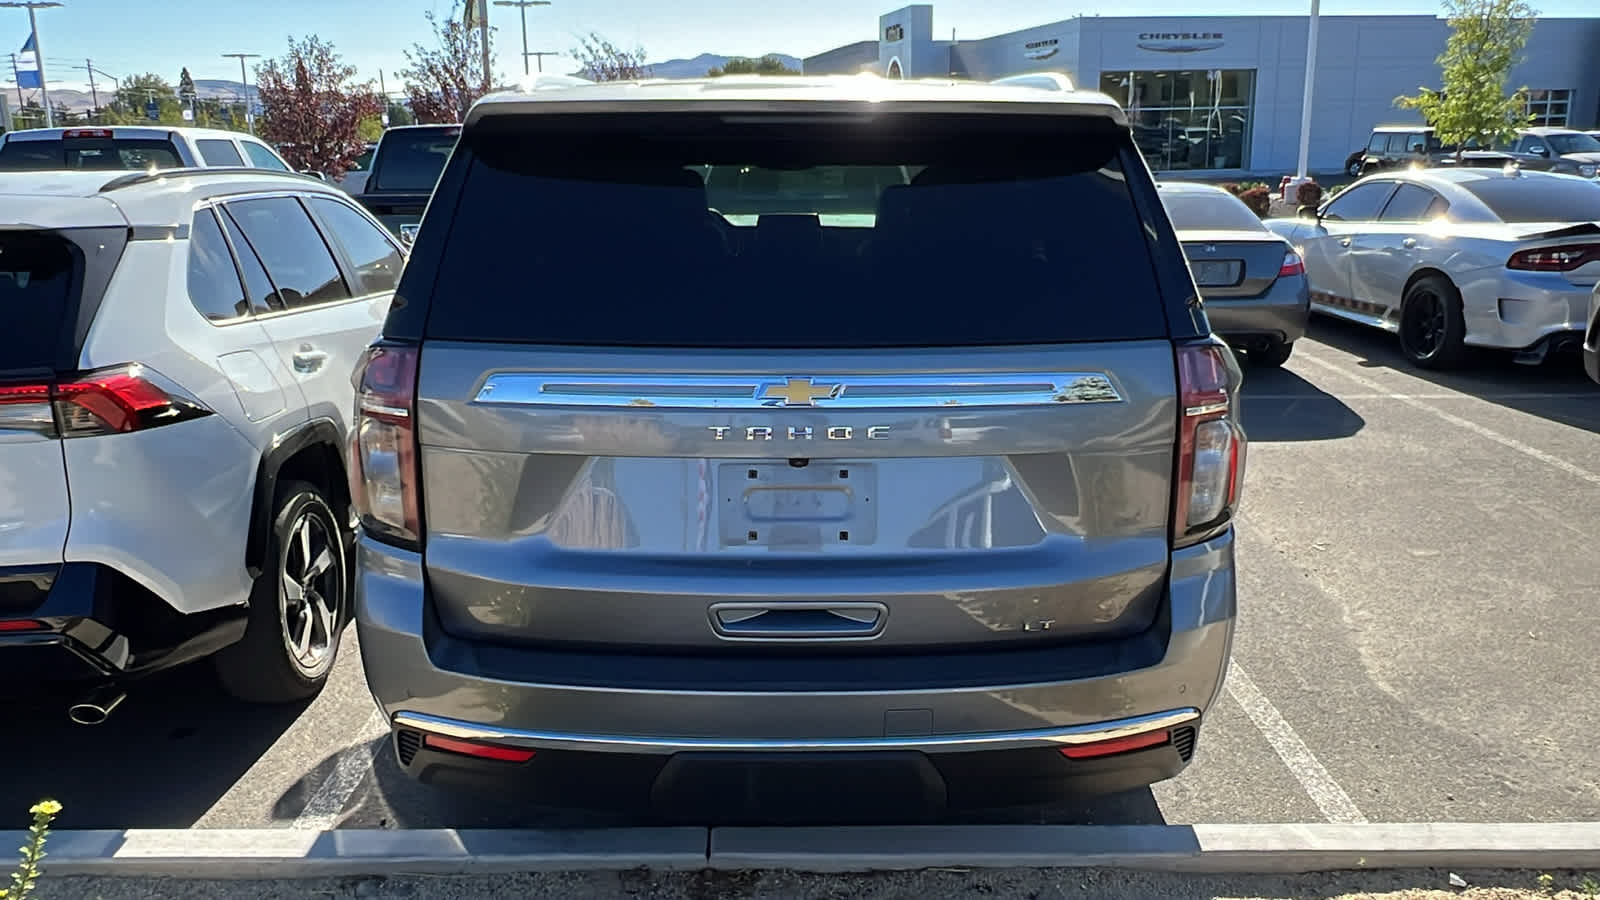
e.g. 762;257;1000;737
1267;168;1600;368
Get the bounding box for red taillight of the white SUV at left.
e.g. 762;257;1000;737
0;365;211;437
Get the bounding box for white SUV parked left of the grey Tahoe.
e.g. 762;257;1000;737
0;168;405;722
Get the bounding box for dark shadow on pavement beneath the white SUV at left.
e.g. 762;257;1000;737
0;663;306;830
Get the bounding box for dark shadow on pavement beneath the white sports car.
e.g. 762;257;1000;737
1305;315;1600;434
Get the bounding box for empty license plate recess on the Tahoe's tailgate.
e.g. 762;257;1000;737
717;461;877;548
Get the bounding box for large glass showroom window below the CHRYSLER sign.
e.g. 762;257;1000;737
1101;69;1256;171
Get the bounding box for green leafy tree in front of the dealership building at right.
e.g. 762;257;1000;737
1395;0;1539;160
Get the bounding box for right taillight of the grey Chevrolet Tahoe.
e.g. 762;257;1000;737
1173;341;1246;546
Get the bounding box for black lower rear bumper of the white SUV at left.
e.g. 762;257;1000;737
0;562;246;684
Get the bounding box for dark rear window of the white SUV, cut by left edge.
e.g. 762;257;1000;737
0;231;77;370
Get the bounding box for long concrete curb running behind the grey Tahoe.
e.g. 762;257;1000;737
9;823;1600;879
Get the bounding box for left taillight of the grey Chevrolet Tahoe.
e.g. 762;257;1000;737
349;344;422;546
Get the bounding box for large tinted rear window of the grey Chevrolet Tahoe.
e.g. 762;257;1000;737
419;115;1166;348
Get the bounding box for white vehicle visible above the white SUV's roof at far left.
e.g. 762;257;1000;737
0;125;290;171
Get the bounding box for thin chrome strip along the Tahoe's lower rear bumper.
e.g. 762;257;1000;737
392;706;1200;753
